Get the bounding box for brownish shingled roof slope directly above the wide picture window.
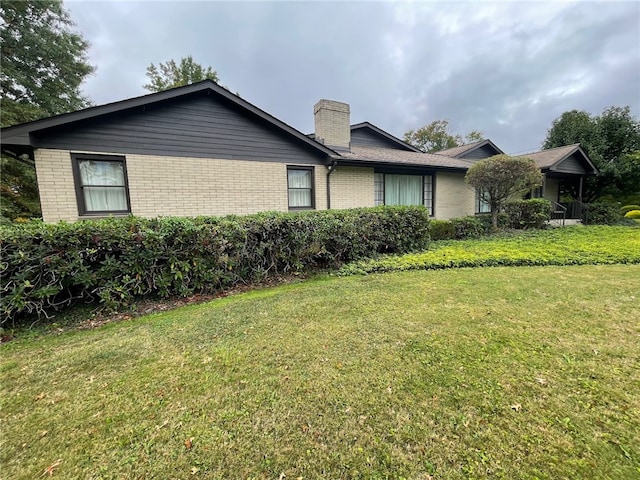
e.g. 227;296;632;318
333;146;471;171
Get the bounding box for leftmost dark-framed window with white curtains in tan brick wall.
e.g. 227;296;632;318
71;154;131;215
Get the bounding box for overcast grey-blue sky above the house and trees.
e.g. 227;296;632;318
65;0;640;153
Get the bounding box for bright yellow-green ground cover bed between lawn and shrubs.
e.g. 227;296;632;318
339;225;640;275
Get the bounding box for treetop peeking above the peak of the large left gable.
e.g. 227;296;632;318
144;55;218;92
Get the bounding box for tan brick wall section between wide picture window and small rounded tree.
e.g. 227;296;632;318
435;172;475;220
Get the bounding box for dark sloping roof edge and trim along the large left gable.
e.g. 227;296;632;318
2;80;336;156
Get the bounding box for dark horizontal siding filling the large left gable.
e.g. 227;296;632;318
35;95;324;164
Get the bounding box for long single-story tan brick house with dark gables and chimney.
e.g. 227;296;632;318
2;80;597;222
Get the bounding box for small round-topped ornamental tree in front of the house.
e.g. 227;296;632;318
465;155;542;231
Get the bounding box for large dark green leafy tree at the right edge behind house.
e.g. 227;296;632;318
543;106;640;202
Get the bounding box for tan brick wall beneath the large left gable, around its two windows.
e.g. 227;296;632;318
36;150;327;222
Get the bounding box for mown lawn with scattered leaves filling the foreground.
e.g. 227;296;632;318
0;265;640;480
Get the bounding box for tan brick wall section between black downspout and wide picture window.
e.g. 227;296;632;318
330;167;375;209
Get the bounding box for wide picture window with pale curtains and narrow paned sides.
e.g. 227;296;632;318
374;173;433;215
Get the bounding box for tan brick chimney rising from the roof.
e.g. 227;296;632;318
313;100;351;150
